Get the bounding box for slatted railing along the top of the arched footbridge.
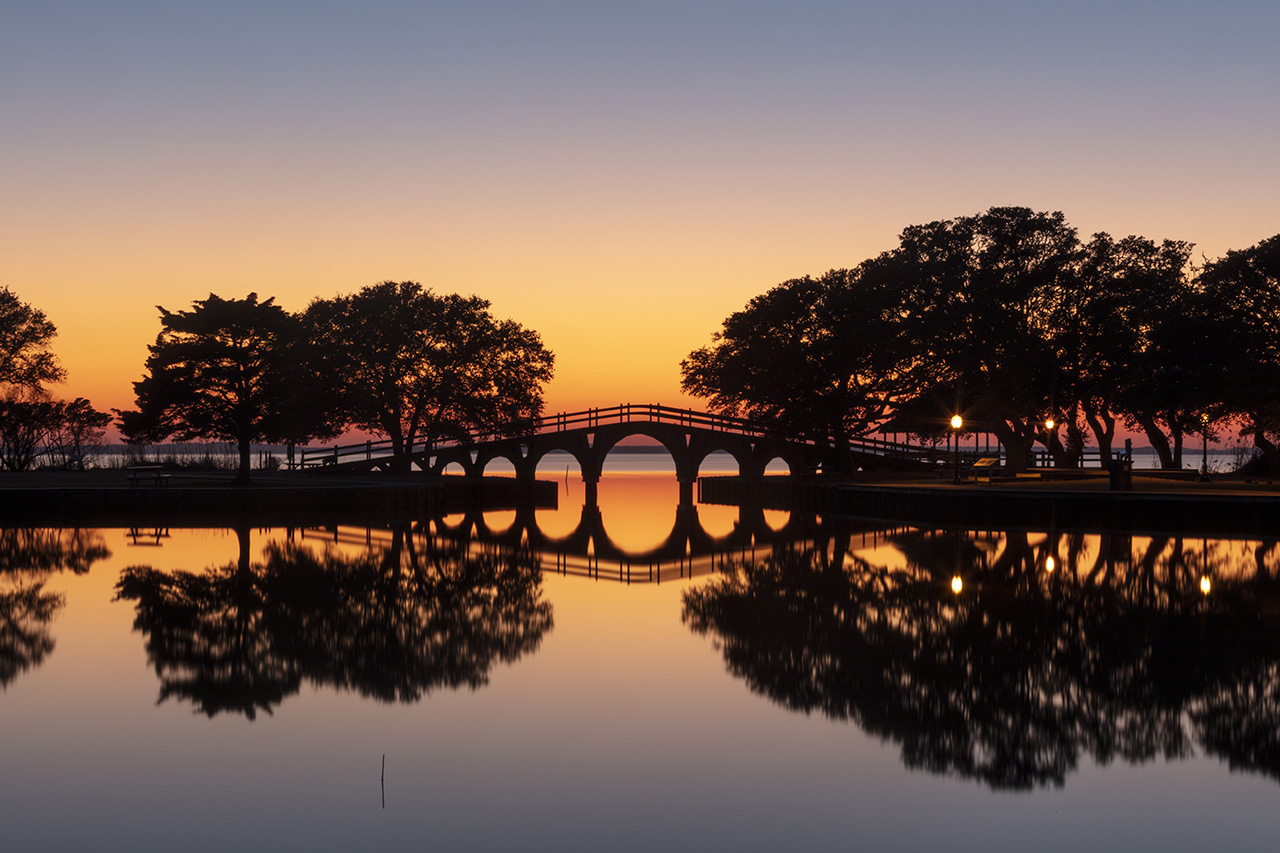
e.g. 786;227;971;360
297;403;951;469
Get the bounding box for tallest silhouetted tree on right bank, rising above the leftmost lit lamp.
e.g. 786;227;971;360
851;207;1079;470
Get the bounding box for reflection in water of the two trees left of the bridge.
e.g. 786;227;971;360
116;530;552;720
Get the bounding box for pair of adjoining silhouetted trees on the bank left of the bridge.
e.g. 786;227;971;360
118;282;554;480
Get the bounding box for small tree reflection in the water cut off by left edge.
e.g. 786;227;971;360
0;528;111;688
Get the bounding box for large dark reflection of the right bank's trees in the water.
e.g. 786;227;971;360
684;532;1280;789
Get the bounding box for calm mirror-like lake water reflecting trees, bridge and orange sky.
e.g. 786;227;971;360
0;455;1280;850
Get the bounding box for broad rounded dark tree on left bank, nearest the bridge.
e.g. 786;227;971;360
306;282;554;467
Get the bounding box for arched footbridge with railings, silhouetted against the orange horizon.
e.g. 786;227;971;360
298;403;951;503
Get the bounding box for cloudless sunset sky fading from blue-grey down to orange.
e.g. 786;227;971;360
0;0;1280;411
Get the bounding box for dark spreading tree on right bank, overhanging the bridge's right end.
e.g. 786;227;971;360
680;269;899;461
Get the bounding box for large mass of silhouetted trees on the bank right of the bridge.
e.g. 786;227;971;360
682;207;1280;473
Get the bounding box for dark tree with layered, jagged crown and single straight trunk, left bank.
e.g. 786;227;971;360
118;293;325;483
